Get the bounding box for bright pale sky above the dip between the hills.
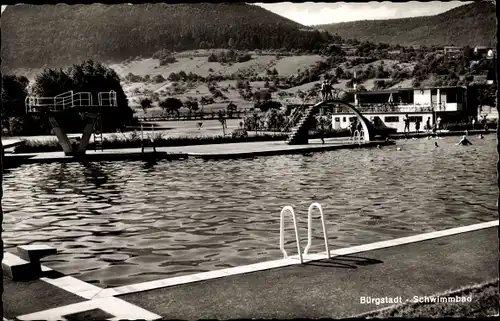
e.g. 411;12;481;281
2;1;471;26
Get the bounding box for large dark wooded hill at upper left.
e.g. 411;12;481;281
1;3;328;70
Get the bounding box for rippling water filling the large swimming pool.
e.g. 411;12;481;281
3;136;498;286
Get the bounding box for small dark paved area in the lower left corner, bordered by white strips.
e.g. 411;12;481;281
3;277;86;319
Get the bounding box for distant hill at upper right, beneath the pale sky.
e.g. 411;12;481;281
316;2;496;46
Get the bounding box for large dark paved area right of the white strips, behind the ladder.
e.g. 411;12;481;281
119;227;499;319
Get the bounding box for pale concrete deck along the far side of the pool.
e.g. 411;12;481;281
4;138;395;165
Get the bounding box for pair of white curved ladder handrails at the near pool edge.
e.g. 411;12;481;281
280;202;330;263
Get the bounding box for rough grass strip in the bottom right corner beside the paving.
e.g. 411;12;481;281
358;279;499;318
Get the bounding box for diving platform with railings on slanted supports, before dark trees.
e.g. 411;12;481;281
25;90;118;156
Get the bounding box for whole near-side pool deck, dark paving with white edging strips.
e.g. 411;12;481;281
4;220;499;320
